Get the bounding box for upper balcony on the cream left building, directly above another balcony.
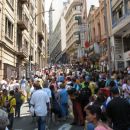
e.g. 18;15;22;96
17;15;28;30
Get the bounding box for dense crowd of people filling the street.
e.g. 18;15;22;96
0;66;130;130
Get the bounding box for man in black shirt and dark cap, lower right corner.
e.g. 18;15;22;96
107;87;130;130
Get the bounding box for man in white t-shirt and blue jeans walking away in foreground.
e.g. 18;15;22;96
30;80;50;130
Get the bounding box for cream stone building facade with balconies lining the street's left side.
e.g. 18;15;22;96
0;0;45;79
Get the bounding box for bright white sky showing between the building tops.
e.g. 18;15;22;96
45;0;99;27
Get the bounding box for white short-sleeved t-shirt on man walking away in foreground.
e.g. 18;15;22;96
30;89;49;116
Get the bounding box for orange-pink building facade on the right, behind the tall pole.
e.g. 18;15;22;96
86;0;112;71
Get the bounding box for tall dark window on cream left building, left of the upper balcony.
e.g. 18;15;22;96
5;17;13;40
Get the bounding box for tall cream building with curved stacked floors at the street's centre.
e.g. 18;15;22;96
65;0;82;63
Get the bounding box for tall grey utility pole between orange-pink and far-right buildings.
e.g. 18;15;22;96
104;0;112;76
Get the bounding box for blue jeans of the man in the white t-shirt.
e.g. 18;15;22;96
38;116;46;130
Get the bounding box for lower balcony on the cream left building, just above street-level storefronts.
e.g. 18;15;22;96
17;46;28;58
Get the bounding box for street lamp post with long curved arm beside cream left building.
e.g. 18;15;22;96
29;9;55;78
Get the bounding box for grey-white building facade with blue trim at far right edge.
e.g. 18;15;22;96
110;0;130;70
